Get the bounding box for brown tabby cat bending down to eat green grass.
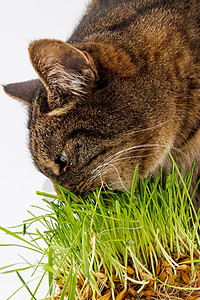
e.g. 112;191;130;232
4;0;200;208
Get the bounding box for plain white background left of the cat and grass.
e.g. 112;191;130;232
0;0;89;300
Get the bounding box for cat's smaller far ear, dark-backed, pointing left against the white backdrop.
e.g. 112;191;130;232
3;79;42;104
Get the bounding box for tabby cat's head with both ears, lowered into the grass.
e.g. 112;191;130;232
4;39;173;193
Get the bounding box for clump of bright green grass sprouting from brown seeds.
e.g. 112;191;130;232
1;164;200;300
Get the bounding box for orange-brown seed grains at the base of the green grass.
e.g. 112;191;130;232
49;253;200;300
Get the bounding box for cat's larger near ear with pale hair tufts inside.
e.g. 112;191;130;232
29;39;98;95
